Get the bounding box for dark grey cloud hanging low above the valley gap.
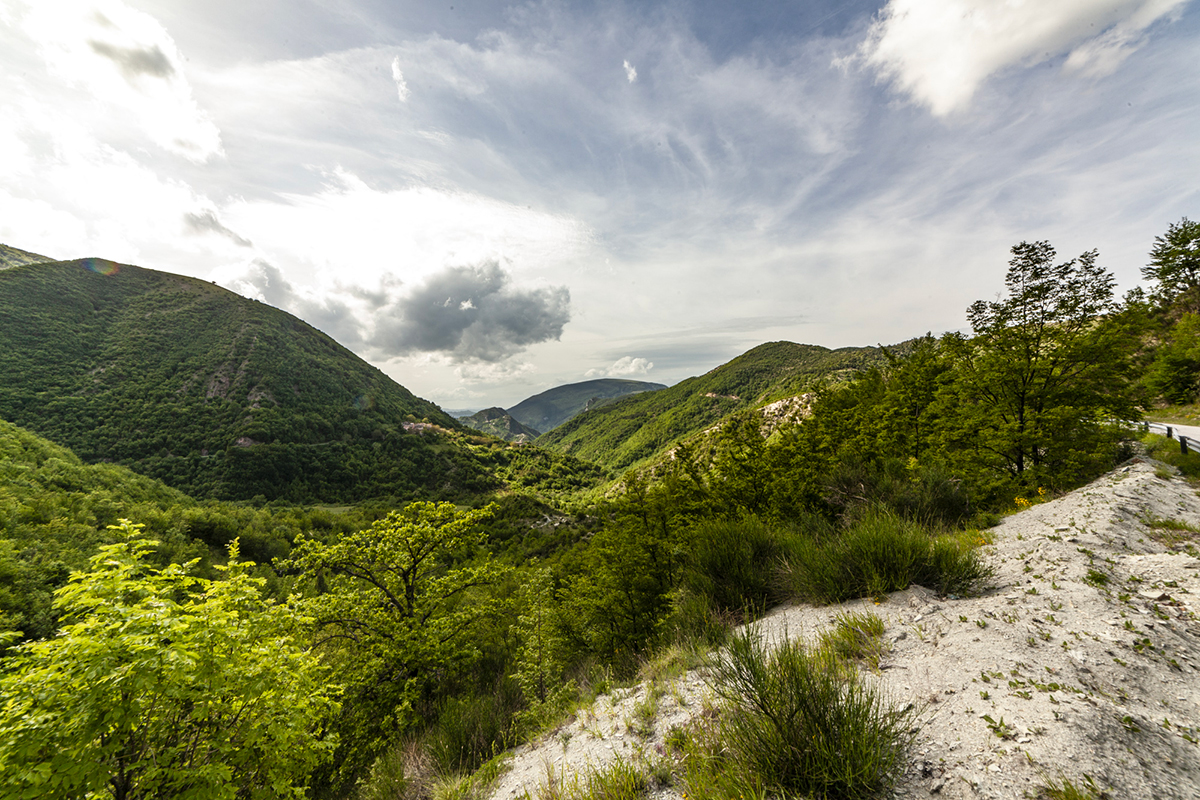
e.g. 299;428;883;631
371;261;571;362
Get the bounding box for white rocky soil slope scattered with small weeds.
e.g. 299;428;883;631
491;461;1200;800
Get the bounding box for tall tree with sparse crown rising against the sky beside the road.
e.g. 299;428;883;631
943;241;1139;487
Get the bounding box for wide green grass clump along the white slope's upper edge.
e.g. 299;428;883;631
787;511;991;603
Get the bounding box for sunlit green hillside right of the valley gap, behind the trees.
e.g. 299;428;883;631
538;342;884;469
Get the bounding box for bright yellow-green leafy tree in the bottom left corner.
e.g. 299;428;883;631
0;521;337;800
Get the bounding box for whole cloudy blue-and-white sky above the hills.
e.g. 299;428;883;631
0;0;1200;409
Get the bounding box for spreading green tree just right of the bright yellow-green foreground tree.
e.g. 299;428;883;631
293;503;502;781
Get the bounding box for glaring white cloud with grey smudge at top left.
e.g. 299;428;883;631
23;0;222;162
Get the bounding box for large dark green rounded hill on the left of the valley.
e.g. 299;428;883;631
0;259;499;501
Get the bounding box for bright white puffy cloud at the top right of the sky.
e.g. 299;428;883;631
857;0;1187;116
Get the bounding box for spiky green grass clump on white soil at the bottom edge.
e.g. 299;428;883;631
684;632;917;800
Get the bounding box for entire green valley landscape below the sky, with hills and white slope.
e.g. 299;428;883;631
0;226;1200;800
